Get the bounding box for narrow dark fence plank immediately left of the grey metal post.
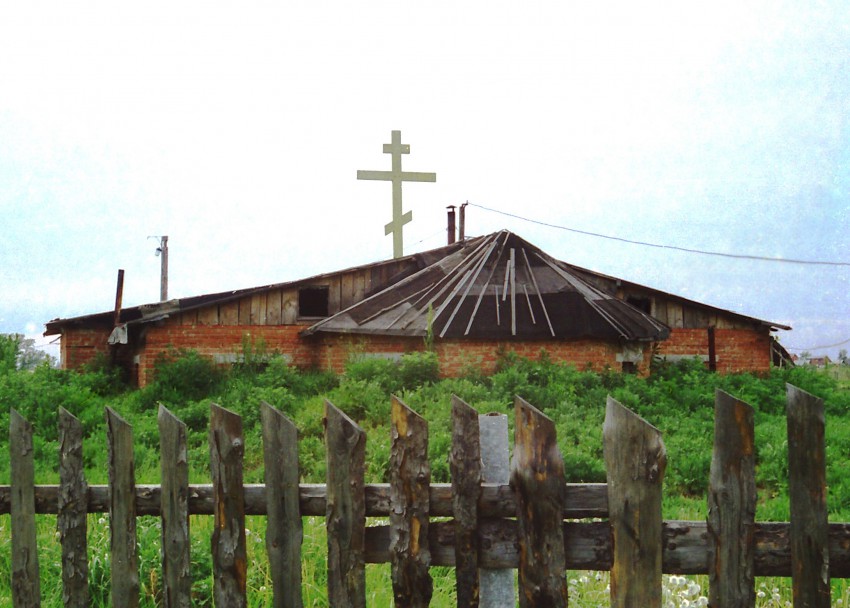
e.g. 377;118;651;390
448;395;481;608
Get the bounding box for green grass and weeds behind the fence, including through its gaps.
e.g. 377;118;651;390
0;356;850;608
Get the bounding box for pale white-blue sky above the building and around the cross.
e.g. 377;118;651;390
0;0;850;358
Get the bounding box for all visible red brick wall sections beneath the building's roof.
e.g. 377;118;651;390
62;319;770;386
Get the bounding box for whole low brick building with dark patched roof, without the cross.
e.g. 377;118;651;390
45;231;790;386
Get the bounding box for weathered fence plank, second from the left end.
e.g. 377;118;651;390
56;407;89;608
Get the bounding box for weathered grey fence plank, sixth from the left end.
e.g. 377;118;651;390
261;402;304;608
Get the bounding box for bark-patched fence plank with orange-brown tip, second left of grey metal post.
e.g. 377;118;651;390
390;396;434;608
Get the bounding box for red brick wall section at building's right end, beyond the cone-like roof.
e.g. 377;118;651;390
658;329;770;373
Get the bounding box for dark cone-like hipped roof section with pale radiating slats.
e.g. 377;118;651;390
303;230;670;341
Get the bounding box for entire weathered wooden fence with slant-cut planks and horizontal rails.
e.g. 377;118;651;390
0;386;850;607
